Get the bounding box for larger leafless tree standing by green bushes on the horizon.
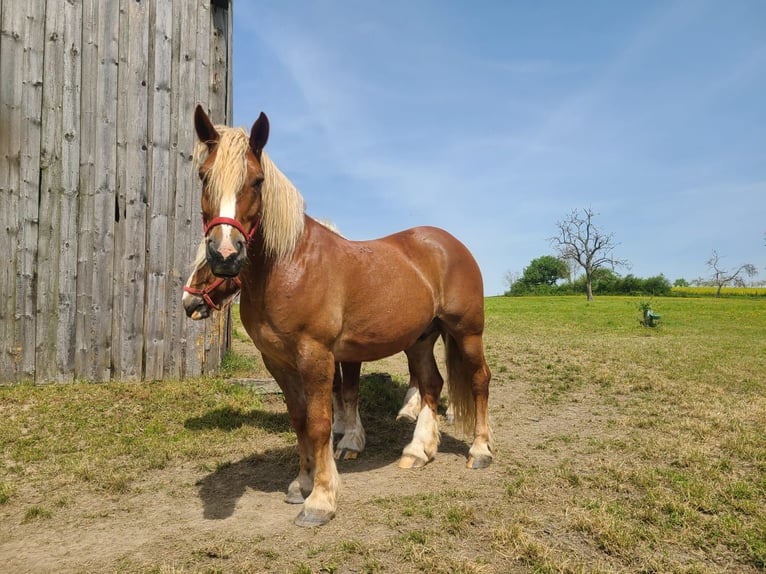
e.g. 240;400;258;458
549;207;630;301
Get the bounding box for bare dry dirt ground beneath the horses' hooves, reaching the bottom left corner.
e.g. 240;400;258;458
0;340;648;573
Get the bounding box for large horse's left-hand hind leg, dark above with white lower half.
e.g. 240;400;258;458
399;332;444;468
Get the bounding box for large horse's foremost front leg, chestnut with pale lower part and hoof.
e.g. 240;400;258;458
295;345;340;526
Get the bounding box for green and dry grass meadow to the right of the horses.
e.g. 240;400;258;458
487;297;766;572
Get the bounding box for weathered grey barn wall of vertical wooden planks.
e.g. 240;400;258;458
0;0;232;383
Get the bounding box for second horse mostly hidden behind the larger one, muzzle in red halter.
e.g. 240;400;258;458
182;258;368;460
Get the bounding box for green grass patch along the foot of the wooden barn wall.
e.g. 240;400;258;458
0;379;289;504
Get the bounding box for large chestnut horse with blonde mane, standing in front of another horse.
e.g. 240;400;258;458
193;106;494;526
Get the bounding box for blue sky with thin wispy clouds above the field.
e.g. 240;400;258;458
234;0;766;295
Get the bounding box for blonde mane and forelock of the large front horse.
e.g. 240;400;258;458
192;126;306;262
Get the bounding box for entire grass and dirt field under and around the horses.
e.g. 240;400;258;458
0;297;766;574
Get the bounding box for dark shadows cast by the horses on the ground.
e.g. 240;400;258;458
184;382;468;520
